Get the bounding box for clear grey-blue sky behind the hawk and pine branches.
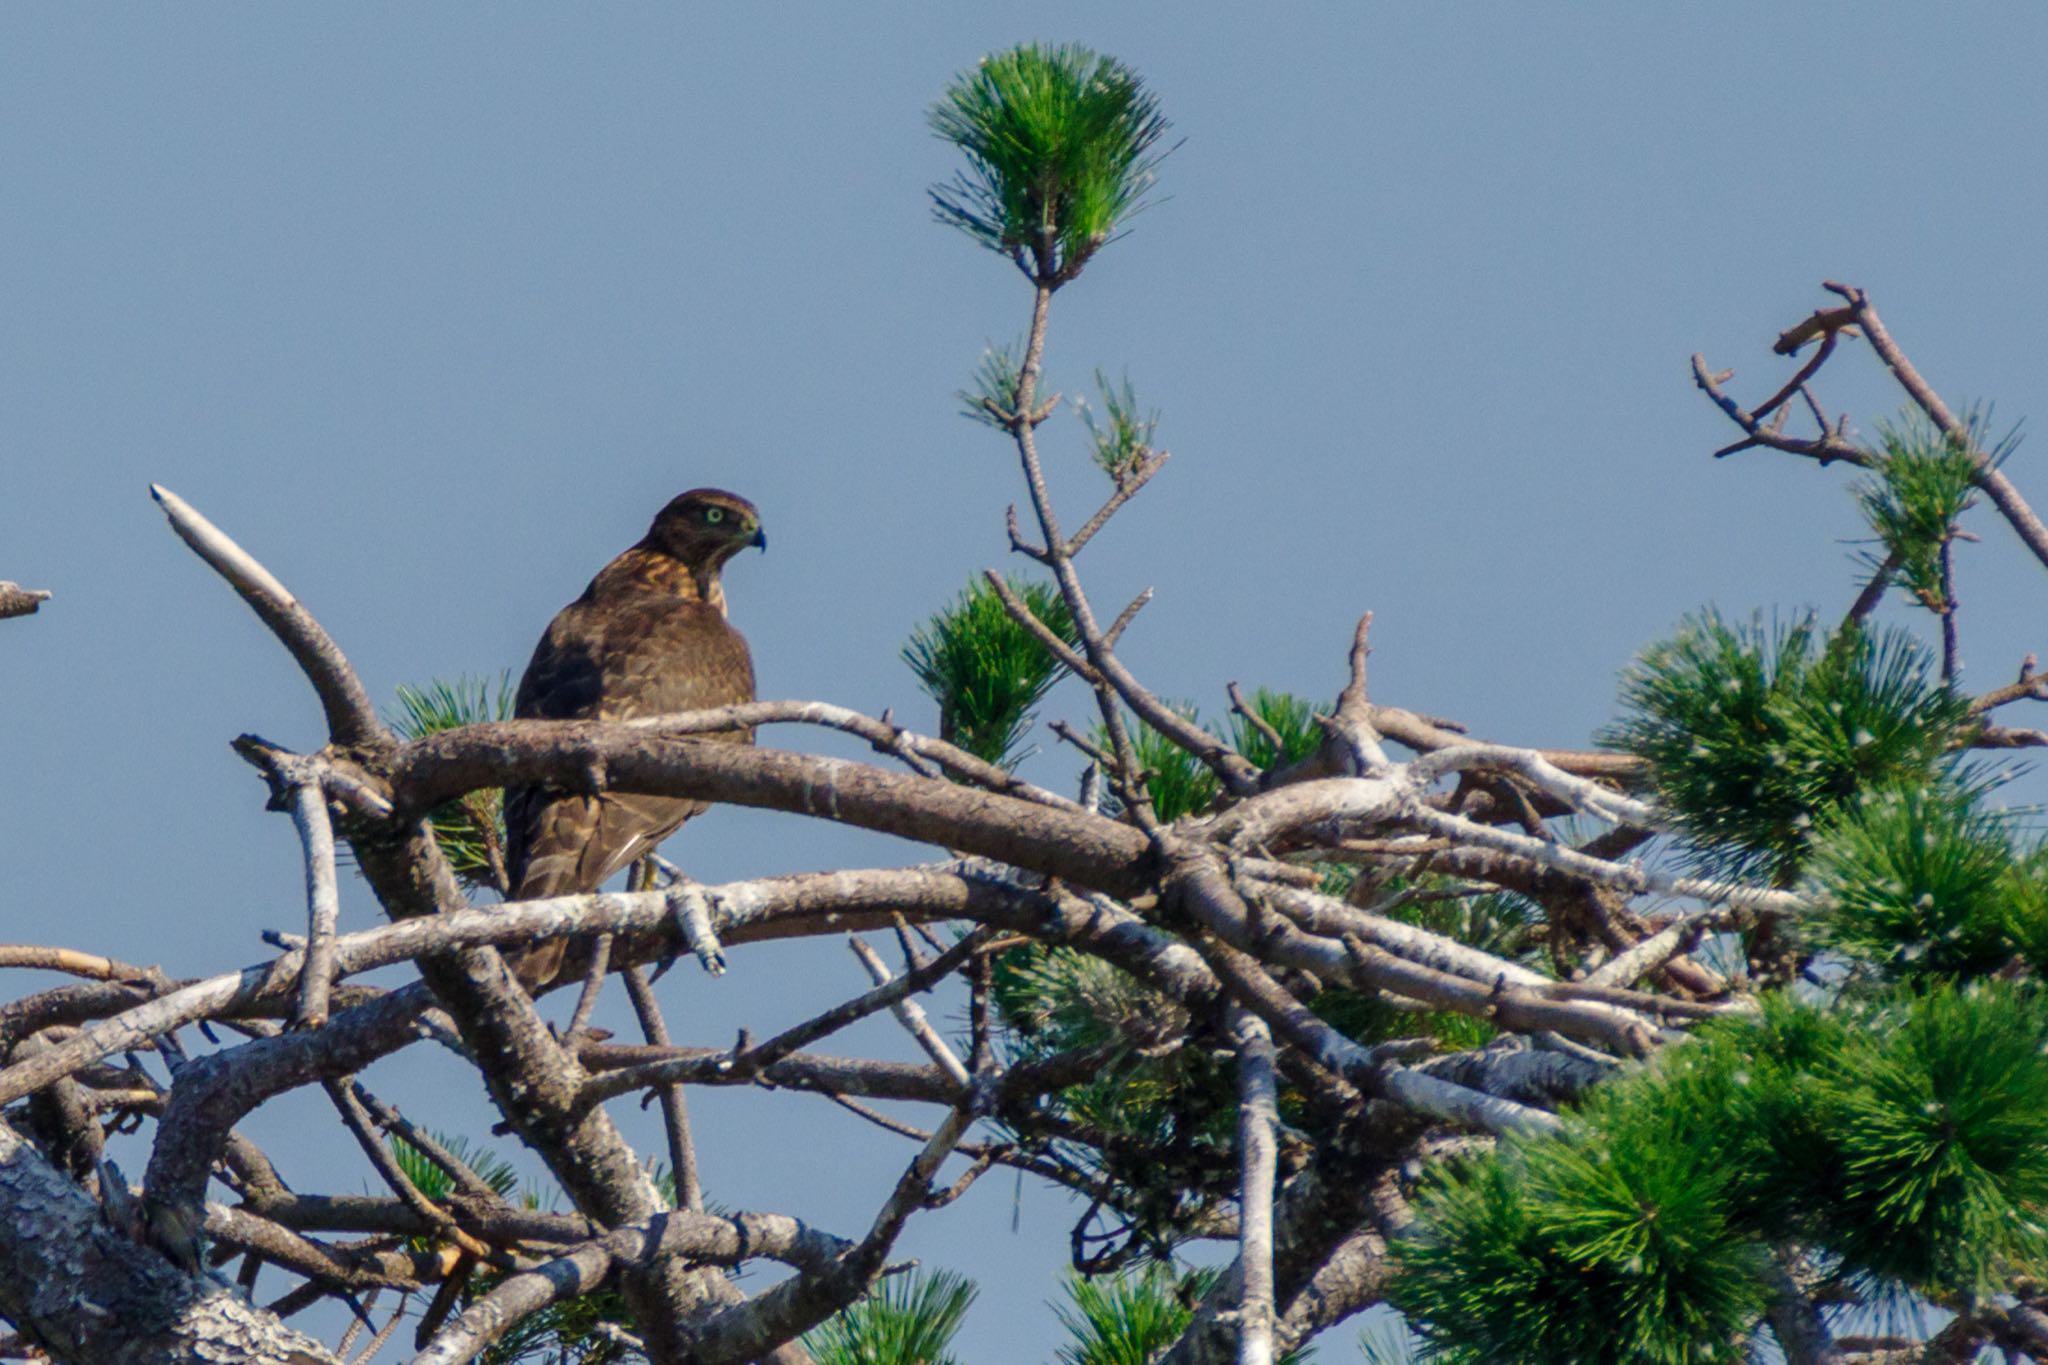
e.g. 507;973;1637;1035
0;4;2048;1361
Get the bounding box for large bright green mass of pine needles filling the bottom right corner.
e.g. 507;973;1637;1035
1393;982;2048;1365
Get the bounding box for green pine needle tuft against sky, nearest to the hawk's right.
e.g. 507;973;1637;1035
903;579;1079;767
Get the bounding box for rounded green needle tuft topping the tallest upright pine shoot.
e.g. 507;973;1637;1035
930;43;1167;289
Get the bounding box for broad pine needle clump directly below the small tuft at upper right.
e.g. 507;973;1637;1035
1602;612;1968;880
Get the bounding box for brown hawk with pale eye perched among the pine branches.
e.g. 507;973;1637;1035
504;489;768;990
